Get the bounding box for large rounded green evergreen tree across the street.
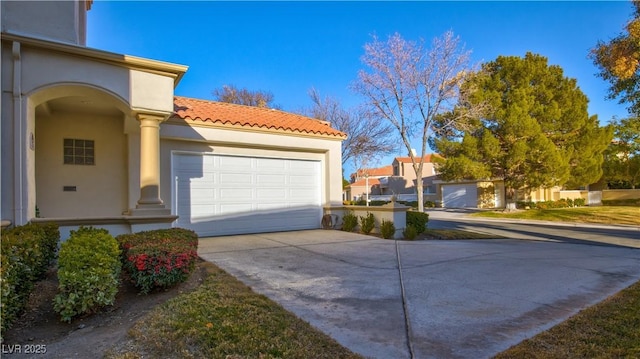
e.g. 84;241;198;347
431;53;611;207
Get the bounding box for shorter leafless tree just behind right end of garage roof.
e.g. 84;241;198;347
306;88;396;165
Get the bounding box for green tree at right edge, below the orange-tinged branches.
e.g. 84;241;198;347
603;118;640;188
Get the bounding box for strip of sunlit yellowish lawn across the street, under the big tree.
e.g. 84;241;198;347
472;206;640;226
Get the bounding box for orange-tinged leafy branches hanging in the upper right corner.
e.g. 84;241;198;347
589;1;640;117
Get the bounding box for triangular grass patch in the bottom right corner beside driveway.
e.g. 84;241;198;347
495;282;640;359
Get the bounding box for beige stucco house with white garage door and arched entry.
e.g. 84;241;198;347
0;1;346;237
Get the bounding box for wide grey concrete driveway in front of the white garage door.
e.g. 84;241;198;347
198;230;640;358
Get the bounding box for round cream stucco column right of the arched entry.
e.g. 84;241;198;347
132;114;169;215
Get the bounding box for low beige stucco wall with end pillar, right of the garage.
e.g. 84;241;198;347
324;202;411;239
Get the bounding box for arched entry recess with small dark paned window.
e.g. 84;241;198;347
29;84;136;218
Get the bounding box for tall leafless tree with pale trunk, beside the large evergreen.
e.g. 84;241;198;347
353;31;482;211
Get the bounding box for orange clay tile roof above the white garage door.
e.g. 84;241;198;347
172;96;347;138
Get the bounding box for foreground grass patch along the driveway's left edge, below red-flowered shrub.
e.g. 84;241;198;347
109;263;360;358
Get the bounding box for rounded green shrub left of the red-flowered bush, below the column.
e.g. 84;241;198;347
53;227;122;322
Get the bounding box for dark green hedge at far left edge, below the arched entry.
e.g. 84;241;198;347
0;223;60;332
